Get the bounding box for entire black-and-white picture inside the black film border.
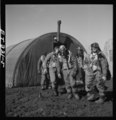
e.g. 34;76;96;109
1;4;113;117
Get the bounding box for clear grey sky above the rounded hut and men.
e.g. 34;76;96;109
5;4;113;52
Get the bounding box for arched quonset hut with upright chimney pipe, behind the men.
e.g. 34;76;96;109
6;21;86;88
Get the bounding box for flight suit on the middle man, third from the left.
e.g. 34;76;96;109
61;51;77;99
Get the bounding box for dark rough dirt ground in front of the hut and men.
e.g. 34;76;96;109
5;80;113;117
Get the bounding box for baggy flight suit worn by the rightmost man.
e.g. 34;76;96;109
86;51;108;100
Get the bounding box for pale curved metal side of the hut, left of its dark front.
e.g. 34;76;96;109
6;40;33;87
